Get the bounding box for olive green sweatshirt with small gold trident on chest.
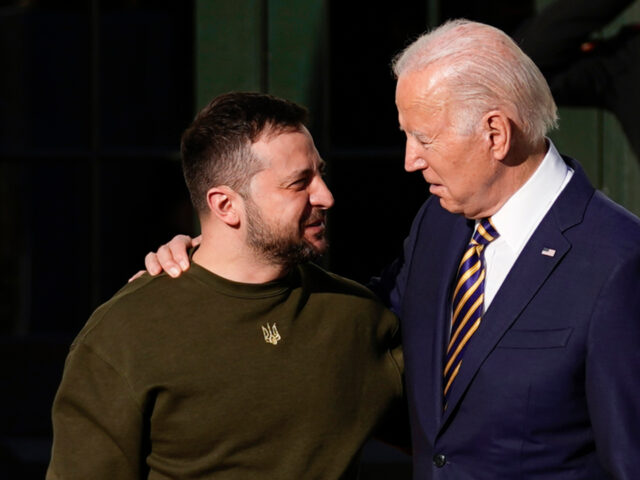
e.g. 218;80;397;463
47;264;402;480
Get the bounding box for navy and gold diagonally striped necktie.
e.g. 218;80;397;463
444;218;500;410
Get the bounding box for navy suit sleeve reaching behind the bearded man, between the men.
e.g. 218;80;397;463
367;200;429;317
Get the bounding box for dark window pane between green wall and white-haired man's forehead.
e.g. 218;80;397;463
329;0;427;149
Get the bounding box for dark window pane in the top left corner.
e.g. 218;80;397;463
0;2;90;153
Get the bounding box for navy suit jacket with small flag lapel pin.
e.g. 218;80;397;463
373;158;640;480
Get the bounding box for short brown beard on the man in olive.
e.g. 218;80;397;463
245;199;327;267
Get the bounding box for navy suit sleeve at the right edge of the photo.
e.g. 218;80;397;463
586;249;640;480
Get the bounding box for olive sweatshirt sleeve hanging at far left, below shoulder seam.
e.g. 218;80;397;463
46;343;146;480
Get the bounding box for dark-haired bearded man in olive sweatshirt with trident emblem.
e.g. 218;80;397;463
47;93;402;480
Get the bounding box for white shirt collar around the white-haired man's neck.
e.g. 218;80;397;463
491;139;573;251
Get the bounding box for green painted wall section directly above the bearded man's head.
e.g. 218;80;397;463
195;0;326;113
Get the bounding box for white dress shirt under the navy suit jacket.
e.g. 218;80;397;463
476;139;573;311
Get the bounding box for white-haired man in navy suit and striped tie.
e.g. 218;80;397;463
141;21;640;480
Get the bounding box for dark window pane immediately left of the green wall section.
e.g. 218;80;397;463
100;2;193;150
